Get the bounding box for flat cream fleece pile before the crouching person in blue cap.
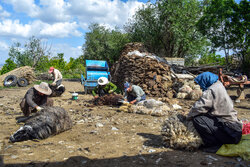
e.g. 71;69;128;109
119;99;170;117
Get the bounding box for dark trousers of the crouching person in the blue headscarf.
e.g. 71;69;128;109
193;115;242;147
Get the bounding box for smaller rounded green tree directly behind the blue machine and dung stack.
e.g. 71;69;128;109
82;24;132;64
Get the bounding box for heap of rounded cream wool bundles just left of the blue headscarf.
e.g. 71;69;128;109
176;81;202;100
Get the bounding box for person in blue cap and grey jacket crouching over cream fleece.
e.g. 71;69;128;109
124;82;146;104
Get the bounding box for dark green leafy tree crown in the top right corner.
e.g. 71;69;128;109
197;0;250;68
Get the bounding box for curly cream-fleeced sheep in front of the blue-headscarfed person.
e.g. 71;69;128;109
161;114;202;151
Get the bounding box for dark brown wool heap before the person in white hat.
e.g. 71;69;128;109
94;93;123;106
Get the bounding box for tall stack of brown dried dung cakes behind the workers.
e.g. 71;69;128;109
111;43;173;98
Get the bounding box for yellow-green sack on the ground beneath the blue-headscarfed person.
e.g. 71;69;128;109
216;134;250;161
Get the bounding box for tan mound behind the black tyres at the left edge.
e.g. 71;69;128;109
0;66;36;86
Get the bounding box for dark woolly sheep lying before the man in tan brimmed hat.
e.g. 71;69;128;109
9;107;73;142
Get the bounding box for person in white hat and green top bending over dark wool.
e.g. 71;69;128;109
92;77;117;99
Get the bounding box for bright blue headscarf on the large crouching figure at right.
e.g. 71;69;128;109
194;72;219;91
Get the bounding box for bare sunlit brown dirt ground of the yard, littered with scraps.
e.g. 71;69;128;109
0;81;250;167
